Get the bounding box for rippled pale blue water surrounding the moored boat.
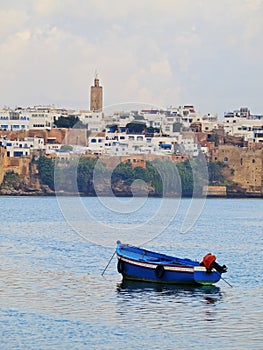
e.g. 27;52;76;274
0;197;263;349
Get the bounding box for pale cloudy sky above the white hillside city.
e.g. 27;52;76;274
0;0;263;118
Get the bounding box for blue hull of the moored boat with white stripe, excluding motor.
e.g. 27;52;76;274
117;245;221;285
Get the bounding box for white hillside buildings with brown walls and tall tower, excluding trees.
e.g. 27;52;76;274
0;76;263;197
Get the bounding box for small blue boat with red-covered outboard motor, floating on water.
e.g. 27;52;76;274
116;241;227;285
